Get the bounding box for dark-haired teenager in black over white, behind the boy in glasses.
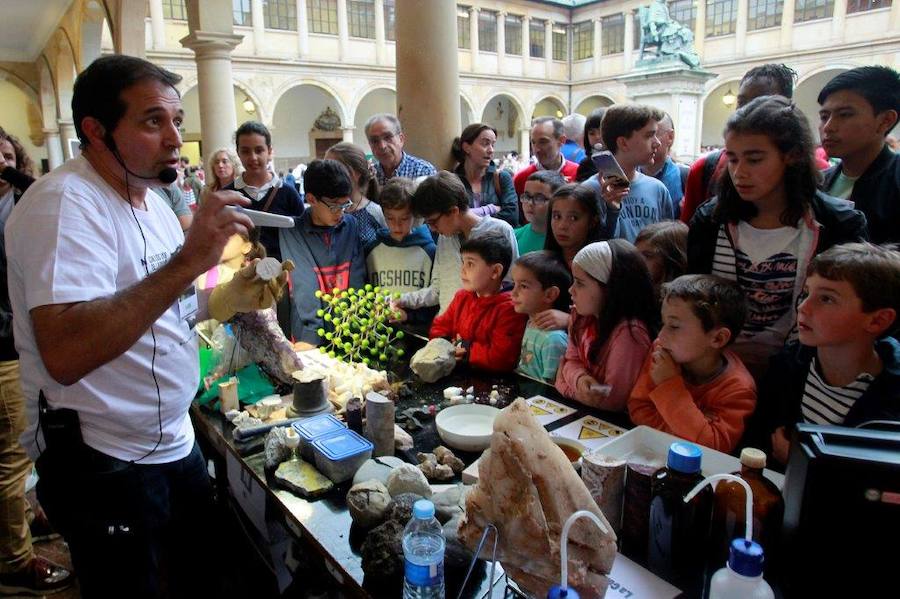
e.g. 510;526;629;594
226;121;303;260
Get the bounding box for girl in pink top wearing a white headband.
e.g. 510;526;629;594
556;239;658;411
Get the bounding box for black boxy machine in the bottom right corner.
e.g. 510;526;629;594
783;423;900;597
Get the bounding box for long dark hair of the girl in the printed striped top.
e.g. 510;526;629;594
715;96;821;227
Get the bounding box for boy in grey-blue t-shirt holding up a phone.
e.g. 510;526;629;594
584;104;675;243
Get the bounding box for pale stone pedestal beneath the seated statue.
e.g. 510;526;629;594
617;57;716;161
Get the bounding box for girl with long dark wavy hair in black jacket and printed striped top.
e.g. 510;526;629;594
688;96;868;378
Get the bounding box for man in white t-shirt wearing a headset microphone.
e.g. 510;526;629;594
6;55;270;597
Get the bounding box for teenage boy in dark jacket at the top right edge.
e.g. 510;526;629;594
818;67;900;243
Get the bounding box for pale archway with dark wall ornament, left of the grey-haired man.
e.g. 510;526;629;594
272;83;346;169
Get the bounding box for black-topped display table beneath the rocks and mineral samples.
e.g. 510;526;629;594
191;340;649;597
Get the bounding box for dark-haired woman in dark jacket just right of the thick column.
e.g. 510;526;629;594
450;123;519;227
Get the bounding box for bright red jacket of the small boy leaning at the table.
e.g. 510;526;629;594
429;289;528;372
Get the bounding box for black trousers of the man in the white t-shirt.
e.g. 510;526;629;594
36;443;221;598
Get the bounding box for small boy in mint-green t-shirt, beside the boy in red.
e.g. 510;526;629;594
510;251;572;385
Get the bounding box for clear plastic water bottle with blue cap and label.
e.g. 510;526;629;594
403;499;445;599
